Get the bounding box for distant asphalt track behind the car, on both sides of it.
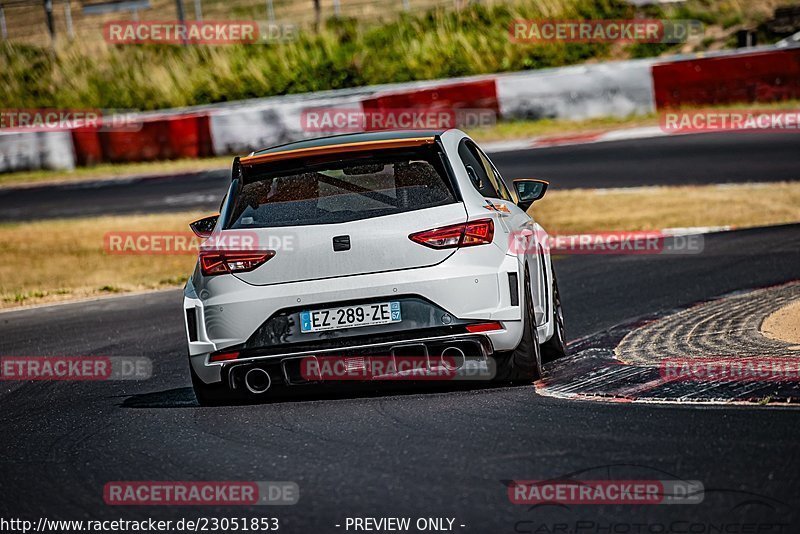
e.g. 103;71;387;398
0;132;800;221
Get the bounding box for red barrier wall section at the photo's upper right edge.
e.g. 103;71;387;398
653;48;800;109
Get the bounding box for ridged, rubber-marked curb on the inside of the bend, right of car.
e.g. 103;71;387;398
535;281;800;406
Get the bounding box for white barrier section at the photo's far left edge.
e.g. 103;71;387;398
0;132;75;172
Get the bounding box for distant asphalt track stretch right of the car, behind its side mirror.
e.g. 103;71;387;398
491;132;800;188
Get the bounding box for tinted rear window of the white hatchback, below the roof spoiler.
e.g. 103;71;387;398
226;147;456;228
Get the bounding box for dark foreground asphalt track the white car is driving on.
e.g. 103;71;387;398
0;225;800;534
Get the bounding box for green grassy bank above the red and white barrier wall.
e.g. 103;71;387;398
0;0;788;110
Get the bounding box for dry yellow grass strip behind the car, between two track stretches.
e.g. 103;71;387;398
0;183;800;308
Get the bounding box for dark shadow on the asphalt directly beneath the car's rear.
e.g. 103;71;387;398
119;382;520;408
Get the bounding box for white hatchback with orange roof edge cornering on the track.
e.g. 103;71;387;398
183;130;565;405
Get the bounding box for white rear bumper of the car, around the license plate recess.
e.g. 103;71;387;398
184;251;524;383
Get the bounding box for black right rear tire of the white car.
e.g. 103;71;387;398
495;268;542;384
